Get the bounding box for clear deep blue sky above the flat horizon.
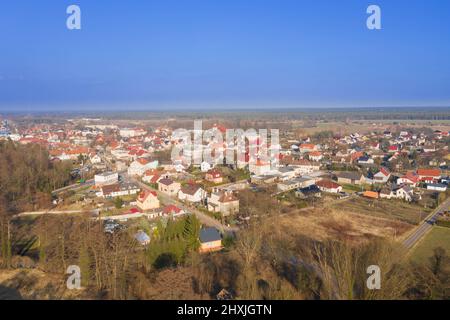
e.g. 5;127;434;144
0;0;450;112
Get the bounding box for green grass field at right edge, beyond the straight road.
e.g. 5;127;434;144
411;227;450;263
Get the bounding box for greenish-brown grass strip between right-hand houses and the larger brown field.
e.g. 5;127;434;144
331;197;429;224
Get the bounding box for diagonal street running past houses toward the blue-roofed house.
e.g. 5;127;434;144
122;174;239;233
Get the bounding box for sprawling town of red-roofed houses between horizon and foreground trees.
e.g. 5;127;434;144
0;109;450;297
